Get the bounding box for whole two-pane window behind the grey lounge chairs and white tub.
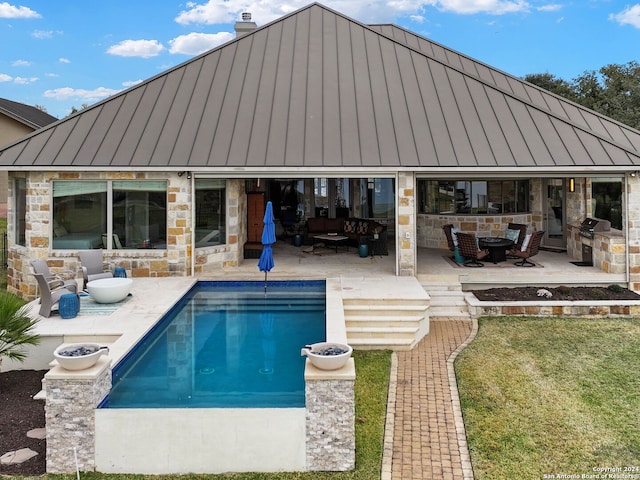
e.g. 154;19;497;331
52;180;167;250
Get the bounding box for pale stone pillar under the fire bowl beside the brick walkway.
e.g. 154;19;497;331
305;358;356;471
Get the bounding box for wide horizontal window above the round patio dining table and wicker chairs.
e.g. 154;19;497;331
418;180;529;215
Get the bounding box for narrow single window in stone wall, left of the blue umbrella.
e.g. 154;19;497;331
195;179;227;247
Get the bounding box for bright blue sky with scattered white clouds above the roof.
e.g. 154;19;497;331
0;0;640;118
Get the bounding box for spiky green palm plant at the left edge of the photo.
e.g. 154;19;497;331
0;291;40;376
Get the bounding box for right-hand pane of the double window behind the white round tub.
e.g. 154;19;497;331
112;181;167;248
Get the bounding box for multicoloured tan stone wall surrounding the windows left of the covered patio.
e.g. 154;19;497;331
7;172;246;299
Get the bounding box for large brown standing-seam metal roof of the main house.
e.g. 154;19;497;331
0;4;640;173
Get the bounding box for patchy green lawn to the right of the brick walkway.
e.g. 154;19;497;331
456;317;640;480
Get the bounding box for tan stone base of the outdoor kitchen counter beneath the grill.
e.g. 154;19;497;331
567;224;627;273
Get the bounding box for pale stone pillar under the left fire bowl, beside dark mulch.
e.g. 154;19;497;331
44;356;111;473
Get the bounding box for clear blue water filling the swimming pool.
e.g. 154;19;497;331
101;281;326;408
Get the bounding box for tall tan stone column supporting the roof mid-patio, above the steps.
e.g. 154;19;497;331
396;172;417;277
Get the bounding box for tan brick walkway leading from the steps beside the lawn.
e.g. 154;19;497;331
383;319;475;480
